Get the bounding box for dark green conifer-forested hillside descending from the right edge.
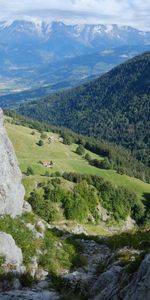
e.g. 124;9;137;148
19;52;150;165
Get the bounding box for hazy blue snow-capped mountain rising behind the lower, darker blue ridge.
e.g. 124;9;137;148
0;20;150;71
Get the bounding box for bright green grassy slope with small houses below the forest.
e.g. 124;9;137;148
6;119;150;197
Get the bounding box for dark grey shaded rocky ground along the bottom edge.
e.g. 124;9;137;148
0;239;150;300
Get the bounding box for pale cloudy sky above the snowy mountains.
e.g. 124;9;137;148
0;0;150;31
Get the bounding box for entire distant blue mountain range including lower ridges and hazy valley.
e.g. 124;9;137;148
0;20;150;100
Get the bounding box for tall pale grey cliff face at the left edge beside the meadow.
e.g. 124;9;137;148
0;109;24;217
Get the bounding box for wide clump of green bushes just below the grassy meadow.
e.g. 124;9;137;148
29;173;145;224
